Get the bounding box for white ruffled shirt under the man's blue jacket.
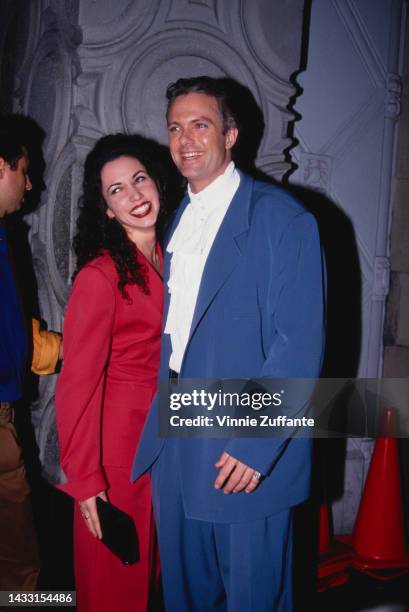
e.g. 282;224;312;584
165;161;240;372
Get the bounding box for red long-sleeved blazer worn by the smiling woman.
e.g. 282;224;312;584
56;252;163;499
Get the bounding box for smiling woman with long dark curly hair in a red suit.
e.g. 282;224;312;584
56;134;164;612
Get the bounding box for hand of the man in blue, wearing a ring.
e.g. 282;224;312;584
214;452;260;495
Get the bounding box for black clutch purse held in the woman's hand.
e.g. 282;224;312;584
96;497;139;565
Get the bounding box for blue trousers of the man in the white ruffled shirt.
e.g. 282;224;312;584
152;440;292;612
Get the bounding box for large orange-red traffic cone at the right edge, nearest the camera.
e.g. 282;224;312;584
352;408;409;580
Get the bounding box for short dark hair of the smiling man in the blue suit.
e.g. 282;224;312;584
166;76;237;134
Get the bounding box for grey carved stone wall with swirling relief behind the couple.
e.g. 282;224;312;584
13;0;310;480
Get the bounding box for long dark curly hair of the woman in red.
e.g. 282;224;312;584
73;134;166;301
